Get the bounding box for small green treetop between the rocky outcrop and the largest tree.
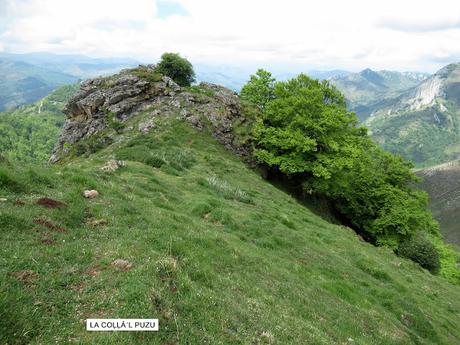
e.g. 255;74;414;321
240;69;275;110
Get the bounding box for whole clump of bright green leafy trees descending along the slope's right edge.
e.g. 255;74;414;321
243;72;439;249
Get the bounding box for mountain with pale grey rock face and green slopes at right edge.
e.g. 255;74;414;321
364;64;460;167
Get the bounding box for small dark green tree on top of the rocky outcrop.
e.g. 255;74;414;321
155;53;195;86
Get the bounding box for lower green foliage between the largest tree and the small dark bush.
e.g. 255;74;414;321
316;140;439;249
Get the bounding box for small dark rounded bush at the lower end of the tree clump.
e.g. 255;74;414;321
398;233;440;273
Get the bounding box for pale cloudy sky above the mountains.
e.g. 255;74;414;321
0;0;460;72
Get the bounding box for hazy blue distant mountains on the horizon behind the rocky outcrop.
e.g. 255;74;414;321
0;53;350;111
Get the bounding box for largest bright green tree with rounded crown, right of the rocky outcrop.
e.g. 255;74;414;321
254;74;367;179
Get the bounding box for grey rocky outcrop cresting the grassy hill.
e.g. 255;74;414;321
50;65;252;163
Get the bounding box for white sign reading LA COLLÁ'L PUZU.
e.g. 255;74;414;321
86;319;158;331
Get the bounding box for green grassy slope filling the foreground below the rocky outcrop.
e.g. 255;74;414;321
0;116;460;345
